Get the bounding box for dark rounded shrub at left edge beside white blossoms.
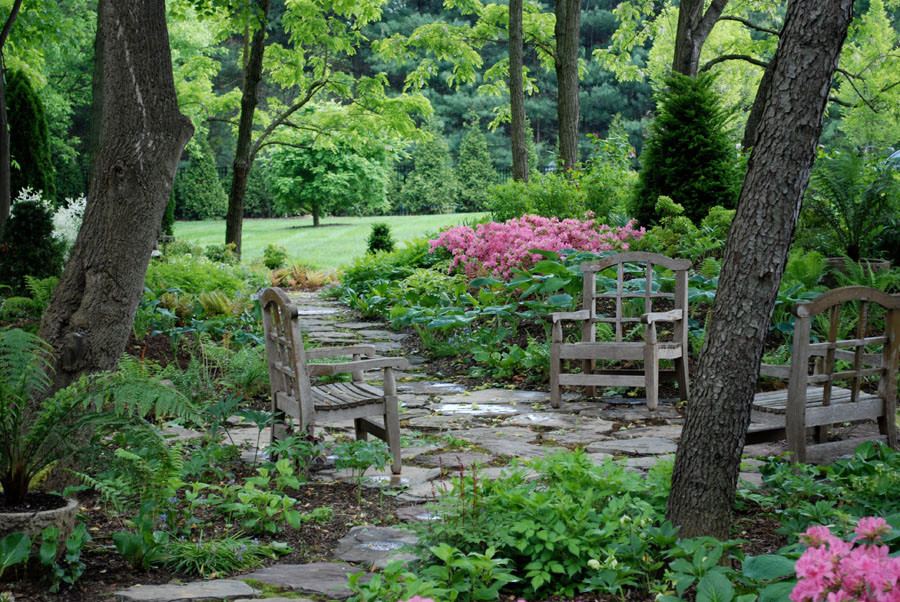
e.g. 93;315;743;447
0;194;65;294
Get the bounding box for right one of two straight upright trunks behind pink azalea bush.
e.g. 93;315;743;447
556;0;581;169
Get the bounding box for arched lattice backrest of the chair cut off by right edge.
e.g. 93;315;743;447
788;286;900;405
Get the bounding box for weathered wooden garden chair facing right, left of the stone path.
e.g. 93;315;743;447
259;288;409;474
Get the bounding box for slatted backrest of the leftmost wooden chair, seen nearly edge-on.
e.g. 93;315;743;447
259;288;315;428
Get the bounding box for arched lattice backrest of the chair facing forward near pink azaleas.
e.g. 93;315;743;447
580;251;691;345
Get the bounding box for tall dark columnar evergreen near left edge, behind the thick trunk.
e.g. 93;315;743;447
6;70;56;201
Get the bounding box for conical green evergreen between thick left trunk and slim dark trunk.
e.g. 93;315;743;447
174;136;228;220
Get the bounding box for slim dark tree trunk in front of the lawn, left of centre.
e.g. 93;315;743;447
225;0;269;257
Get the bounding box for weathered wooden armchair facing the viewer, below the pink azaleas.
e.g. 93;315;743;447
550;252;691;410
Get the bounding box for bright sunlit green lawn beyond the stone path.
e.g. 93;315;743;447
175;213;486;268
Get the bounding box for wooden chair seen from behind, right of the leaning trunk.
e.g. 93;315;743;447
750;286;900;463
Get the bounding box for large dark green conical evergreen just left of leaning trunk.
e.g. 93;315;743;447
631;73;741;226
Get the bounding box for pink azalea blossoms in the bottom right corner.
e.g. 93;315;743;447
790;517;900;602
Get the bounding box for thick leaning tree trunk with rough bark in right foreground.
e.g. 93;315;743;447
668;0;853;539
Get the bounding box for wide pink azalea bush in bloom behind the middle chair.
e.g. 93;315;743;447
429;214;644;279
